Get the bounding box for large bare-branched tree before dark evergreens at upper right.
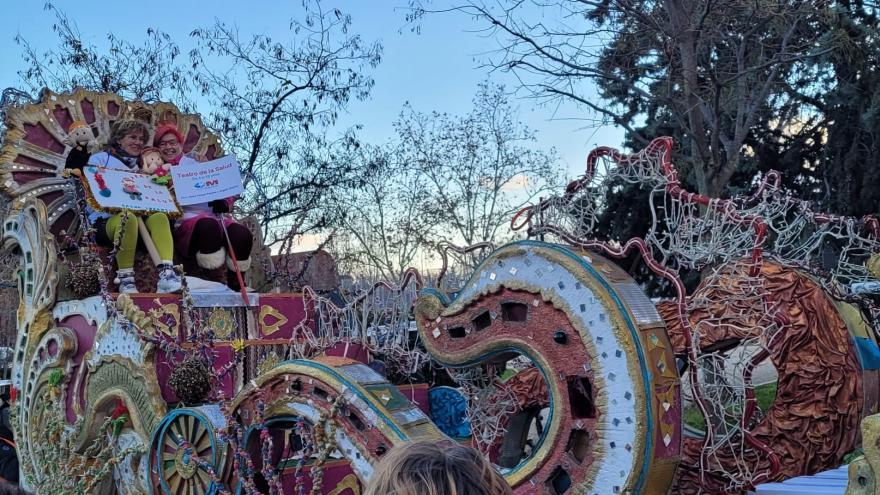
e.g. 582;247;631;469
413;0;836;200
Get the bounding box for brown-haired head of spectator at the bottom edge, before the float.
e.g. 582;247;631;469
364;442;513;495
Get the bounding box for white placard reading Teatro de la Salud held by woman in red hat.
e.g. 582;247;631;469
171;156;244;205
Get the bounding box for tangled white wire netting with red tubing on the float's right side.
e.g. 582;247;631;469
511;137;880;493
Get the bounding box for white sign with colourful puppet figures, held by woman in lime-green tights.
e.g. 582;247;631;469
82;165;180;214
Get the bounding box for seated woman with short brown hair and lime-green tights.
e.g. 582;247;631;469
88;120;180;293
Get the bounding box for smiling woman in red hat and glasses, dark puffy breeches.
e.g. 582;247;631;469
153;123;254;289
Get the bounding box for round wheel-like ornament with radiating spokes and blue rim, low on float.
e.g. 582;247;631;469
149;406;223;495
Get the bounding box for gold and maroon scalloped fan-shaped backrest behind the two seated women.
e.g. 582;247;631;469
0;88;222;241
